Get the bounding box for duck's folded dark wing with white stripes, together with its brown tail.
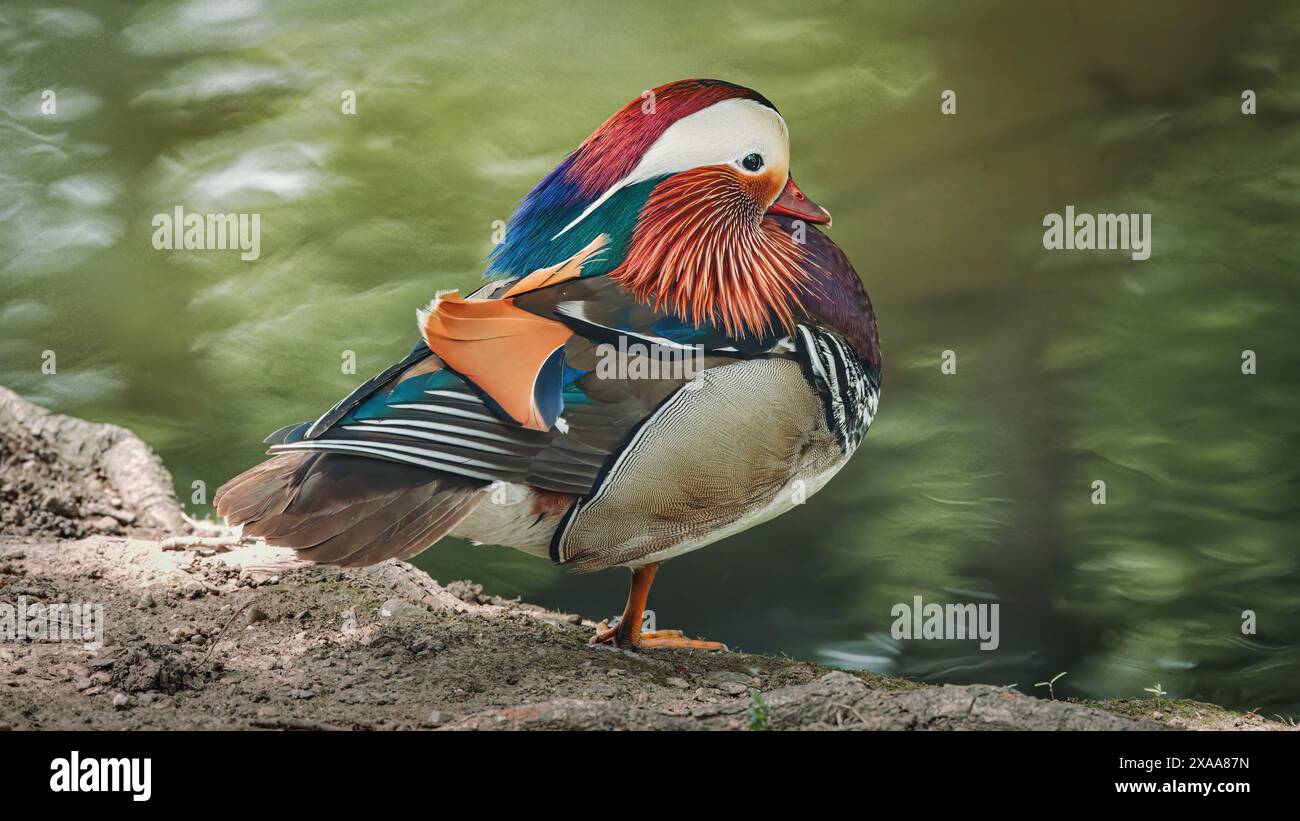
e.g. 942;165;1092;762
215;319;707;565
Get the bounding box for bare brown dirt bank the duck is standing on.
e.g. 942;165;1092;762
0;388;1286;730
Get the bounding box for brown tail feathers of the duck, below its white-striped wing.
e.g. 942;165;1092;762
215;451;486;566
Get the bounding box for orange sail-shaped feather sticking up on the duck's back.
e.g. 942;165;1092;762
417;234;608;430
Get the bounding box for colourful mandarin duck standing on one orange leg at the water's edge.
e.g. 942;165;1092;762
215;79;881;650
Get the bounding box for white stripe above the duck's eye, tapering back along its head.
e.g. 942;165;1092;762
551;99;790;239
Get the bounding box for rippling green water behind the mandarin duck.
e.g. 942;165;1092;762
0;0;1300;714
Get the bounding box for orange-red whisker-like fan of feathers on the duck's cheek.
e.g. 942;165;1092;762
610;166;807;335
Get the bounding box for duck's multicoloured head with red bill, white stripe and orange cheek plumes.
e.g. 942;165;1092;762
489;79;831;334
